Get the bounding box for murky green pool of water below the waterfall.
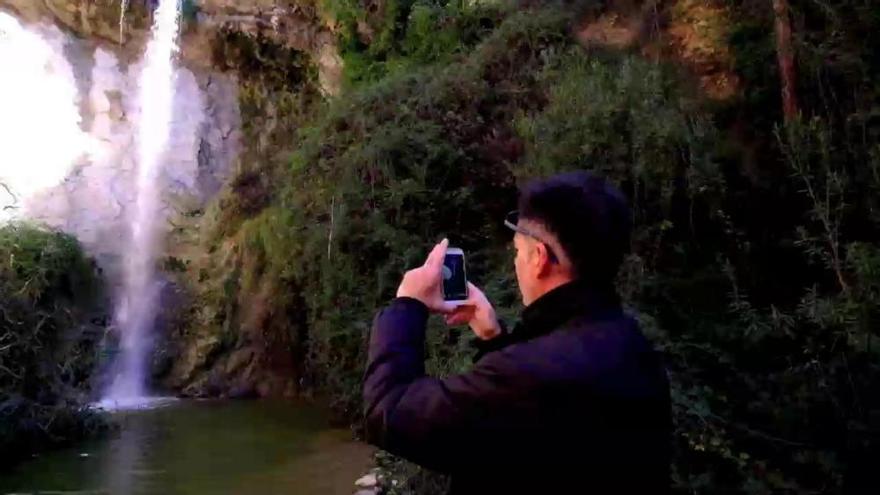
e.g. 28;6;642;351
0;401;371;495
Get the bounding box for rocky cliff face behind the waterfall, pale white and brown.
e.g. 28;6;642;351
0;0;342;395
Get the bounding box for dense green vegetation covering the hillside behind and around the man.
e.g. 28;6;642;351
163;0;880;493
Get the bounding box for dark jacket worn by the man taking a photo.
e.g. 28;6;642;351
364;283;671;494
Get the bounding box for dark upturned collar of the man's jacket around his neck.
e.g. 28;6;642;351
513;280;623;340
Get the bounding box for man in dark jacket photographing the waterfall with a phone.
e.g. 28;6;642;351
364;172;671;494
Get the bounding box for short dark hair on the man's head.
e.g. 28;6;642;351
519;171;632;284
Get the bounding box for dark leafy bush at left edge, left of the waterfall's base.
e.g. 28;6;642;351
0;224;104;468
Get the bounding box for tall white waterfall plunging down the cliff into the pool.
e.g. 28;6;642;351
101;0;180;408
